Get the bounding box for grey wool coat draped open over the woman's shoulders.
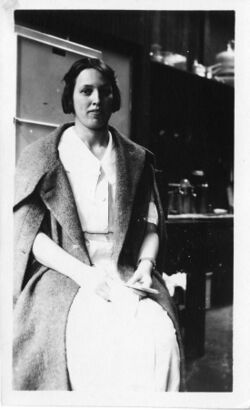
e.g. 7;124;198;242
13;123;184;390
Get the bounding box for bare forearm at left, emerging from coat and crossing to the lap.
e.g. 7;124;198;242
32;233;105;288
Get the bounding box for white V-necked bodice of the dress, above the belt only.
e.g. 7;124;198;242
58;127;116;233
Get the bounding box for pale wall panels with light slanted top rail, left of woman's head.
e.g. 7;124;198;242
16;27;102;159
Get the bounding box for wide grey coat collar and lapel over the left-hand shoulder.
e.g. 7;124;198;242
15;123;90;263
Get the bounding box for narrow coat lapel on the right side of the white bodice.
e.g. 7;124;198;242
111;128;145;261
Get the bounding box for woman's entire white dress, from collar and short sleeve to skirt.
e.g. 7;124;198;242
59;127;180;391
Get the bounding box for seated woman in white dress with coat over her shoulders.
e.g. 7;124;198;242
13;58;186;391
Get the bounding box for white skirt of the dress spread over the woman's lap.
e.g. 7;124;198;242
66;286;180;392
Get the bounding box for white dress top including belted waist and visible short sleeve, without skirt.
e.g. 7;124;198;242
58;127;158;266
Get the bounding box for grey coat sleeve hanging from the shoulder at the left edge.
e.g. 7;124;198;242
13;138;57;303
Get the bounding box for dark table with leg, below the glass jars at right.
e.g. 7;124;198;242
165;215;233;358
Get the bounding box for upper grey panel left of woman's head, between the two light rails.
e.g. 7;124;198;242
17;38;80;124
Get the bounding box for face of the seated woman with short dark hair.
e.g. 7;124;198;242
73;68;113;130
